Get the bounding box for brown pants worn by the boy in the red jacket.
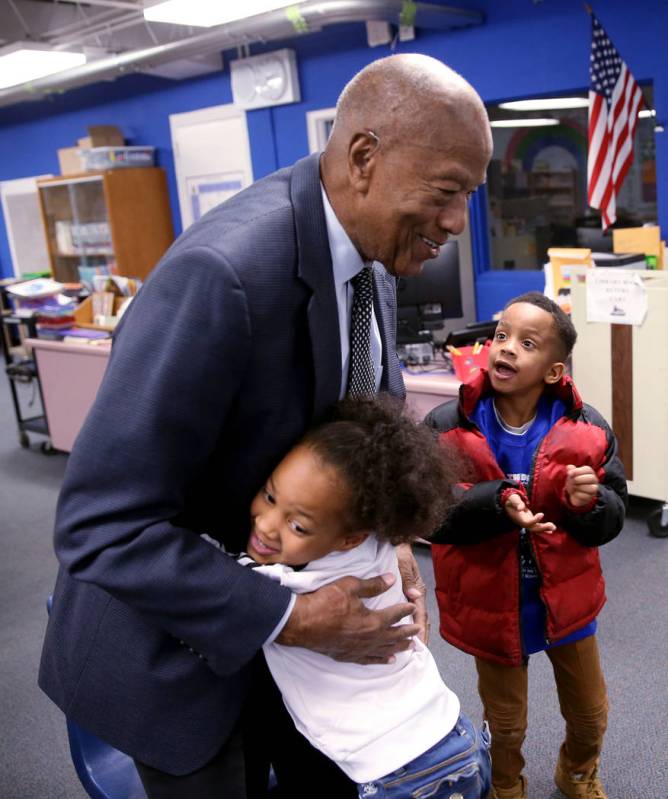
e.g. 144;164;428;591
475;635;608;790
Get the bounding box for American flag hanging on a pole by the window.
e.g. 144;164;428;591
587;14;644;228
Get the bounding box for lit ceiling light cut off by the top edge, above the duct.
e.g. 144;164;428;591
144;0;295;28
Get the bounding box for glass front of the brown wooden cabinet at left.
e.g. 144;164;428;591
39;175;115;283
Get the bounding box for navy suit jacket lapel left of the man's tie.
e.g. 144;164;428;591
290;154;341;420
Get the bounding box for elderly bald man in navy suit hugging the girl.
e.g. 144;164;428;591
40;55;491;799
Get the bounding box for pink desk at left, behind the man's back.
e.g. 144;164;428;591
24;338;111;452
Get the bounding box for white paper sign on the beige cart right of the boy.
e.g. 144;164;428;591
587;268;647;325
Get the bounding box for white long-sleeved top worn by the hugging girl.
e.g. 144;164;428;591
242;536;459;783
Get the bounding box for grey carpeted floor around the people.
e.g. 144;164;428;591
0;375;668;799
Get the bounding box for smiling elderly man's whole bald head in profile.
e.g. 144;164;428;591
320;55;492;277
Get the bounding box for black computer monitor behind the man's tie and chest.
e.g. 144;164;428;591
397;241;464;344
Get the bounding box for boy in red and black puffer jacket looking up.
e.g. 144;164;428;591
427;292;627;799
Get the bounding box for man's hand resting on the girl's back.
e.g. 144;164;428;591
276;574;420;664
